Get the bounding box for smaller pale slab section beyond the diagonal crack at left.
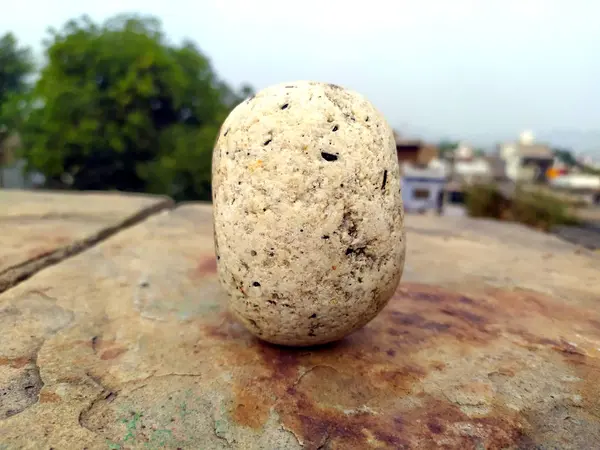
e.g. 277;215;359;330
0;190;172;292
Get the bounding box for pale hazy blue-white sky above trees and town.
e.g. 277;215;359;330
0;0;600;155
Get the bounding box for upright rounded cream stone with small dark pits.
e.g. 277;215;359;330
212;81;405;346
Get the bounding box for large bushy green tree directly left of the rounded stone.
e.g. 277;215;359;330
25;15;252;200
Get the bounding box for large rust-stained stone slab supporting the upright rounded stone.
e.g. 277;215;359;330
0;198;600;450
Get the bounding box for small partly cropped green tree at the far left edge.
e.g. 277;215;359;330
0;33;34;164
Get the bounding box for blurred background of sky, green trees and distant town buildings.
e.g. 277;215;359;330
0;0;600;248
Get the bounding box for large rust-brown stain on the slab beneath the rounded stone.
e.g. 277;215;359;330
204;284;600;449
